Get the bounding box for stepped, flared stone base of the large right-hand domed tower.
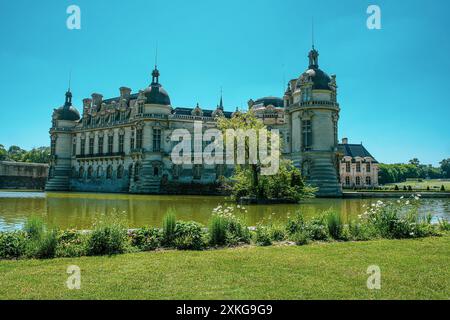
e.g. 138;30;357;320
308;155;342;197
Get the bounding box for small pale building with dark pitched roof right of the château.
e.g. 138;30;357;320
338;138;379;189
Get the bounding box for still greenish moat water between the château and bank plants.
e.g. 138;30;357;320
0;191;450;231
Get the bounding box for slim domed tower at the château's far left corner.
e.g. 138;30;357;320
45;89;80;191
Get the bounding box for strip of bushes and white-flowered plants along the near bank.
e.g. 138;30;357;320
0;196;450;259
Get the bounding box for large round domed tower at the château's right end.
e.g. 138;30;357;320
283;46;342;197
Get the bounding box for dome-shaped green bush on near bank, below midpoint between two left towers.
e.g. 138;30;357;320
86;220;127;256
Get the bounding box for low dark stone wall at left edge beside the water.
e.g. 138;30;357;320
0;161;48;189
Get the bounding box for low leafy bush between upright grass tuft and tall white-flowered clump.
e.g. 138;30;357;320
173;221;205;250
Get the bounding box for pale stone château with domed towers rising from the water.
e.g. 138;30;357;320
46;48;376;196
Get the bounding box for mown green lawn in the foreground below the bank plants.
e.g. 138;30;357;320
0;236;450;299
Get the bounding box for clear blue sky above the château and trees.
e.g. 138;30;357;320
0;0;450;164
